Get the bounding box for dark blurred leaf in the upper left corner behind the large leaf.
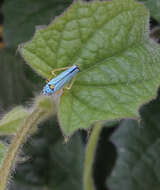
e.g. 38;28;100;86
3;0;72;47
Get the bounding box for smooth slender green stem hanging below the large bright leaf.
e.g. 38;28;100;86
84;123;102;190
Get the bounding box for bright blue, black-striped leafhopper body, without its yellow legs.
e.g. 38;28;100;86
43;65;79;95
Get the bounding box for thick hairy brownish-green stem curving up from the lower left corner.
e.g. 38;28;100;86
0;108;46;190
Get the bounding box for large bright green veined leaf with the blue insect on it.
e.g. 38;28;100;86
20;0;160;135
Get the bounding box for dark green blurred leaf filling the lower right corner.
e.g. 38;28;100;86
108;99;160;190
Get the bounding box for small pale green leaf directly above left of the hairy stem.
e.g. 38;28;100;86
0;106;29;134
